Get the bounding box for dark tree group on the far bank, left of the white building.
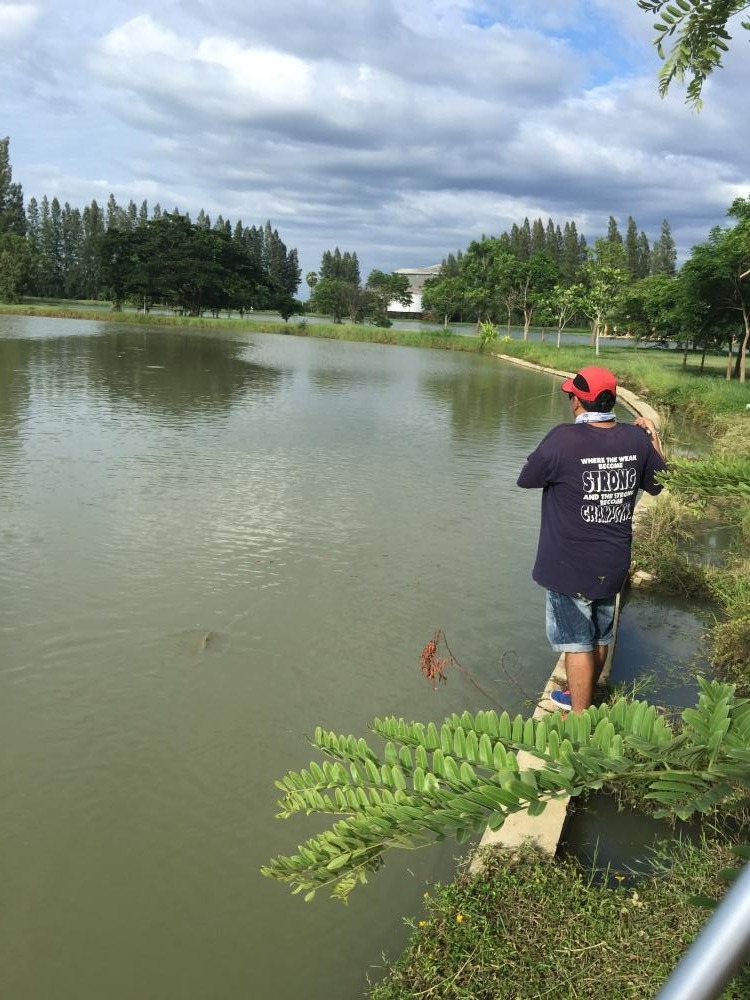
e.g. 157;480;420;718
0;138;301;317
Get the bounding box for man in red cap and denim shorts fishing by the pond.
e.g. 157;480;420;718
518;367;666;712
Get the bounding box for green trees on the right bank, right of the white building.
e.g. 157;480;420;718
422;198;750;381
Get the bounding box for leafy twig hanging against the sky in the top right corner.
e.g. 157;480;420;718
638;0;750;108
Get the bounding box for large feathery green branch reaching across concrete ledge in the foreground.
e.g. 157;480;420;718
261;679;750;901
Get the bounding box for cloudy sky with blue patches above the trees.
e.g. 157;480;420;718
0;0;750;282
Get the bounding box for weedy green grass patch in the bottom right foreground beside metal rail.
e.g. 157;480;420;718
370;841;750;1000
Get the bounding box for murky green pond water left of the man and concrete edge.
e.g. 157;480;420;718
0;317;704;1000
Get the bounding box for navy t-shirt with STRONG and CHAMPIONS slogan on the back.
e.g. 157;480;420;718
518;423;666;600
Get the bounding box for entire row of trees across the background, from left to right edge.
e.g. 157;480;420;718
0;138;750;381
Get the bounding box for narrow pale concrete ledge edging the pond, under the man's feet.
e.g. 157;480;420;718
469;354;661;872
